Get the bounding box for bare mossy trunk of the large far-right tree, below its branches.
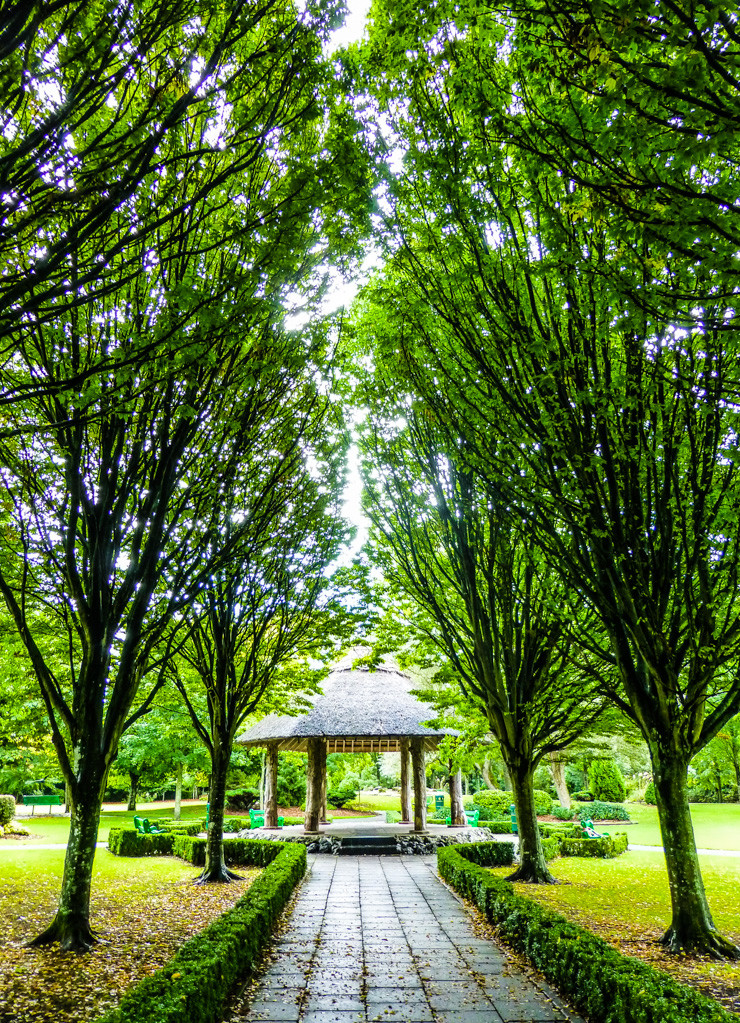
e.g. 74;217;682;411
650;746;740;959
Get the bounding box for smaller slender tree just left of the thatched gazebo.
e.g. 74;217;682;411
172;386;346;884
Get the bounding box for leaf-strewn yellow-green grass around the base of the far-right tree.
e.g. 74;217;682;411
492;851;740;1012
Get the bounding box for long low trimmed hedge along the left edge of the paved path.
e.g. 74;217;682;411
99;836;306;1023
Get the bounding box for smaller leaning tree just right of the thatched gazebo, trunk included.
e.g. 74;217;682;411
358;398;603;883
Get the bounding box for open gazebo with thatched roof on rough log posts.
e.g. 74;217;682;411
236;658;465;834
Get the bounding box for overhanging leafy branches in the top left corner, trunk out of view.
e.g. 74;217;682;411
0;0;366;390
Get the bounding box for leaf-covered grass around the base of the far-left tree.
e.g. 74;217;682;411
0;847;260;1023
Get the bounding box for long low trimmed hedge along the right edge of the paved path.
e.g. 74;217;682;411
437;843;737;1023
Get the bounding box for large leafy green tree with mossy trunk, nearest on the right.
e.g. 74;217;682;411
354;5;740;958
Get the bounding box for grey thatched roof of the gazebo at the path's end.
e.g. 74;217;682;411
236;661;455;753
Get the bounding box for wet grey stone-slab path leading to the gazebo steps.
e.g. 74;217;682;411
228;856;582;1023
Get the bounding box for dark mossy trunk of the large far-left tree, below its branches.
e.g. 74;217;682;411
29;776;104;952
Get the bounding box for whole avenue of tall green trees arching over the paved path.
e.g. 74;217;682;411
0;0;740;958
